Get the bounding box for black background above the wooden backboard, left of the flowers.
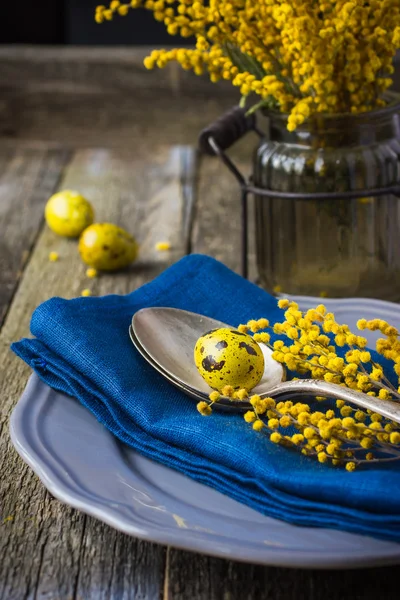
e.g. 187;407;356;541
0;0;184;46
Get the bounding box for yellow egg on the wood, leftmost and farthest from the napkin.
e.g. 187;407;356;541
44;190;94;237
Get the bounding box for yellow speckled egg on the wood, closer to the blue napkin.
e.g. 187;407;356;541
79;223;139;271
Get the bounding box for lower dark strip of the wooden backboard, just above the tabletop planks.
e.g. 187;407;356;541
0;90;238;148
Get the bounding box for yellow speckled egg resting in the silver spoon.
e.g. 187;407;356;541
194;328;264;390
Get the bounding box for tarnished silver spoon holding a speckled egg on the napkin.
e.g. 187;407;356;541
132;307;400;423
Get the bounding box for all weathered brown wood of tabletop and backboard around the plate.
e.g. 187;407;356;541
0;48;399;600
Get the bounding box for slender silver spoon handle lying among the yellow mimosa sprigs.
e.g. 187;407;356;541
262;379;400;423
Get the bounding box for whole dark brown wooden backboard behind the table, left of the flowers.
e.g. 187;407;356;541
0;47;239;148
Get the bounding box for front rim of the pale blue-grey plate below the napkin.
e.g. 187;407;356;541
10;376;400;570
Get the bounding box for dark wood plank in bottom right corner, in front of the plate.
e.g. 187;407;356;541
164;549;398;600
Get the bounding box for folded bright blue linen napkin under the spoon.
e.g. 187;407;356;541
12;255;400;542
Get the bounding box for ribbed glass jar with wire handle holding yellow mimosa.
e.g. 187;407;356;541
253;95;400;301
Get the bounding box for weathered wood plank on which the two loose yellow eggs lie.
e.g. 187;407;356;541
0;143;195;600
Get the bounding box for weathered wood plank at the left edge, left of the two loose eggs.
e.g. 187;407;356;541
0;147;69;326
